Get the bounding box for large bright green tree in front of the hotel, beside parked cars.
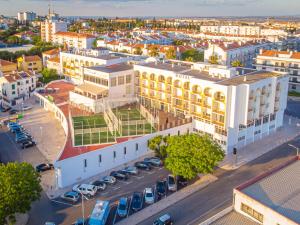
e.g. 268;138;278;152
165;133;225;179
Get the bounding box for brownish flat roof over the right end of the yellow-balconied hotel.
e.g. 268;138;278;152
218;71;282;86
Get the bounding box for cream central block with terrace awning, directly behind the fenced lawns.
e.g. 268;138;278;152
70;63;135;113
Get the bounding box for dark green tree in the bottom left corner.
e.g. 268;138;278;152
0;162;42;224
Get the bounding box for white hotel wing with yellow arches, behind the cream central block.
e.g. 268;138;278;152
60;49;131;84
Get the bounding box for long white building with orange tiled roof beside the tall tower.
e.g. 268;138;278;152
53;31;96;49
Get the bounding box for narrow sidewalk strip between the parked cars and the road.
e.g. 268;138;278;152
118;174;217;225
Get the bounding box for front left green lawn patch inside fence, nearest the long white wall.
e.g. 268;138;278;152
75;132;115;146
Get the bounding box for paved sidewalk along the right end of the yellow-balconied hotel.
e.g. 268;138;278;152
219;116;300;170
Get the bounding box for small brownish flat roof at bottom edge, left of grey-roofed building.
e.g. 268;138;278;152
210;211;259;225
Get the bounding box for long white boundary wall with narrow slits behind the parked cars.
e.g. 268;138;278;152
55;123;192;188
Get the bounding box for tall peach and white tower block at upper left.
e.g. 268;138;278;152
41;20;68;42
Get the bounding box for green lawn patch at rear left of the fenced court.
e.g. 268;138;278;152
73;114;107;130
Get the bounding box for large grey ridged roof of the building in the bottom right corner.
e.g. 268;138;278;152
239;160;300;223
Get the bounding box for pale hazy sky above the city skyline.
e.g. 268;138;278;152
0;0;300;17
